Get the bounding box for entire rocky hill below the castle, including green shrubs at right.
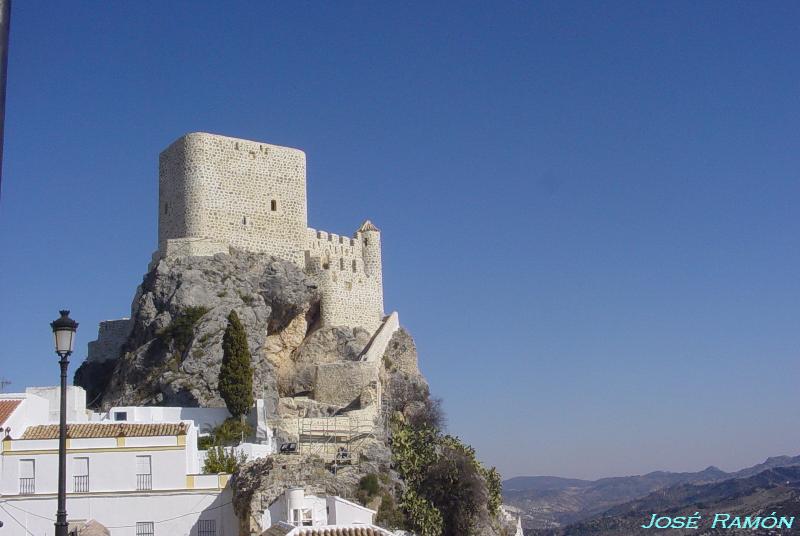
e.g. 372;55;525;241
75;248;516;536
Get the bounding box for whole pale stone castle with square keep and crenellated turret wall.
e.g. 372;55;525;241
153;132;383;333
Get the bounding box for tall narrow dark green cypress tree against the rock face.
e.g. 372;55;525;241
219;311;253;419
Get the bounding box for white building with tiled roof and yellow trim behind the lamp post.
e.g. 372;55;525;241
0;389;238;536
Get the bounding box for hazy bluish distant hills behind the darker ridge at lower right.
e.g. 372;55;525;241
503;456;800;534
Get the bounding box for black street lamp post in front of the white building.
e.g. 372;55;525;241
50;311;78;536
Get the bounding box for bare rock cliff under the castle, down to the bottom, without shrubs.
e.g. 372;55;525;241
75;249;513;536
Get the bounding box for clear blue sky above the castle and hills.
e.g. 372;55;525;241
0;1;800;477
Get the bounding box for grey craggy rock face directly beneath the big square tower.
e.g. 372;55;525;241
76;250;319;407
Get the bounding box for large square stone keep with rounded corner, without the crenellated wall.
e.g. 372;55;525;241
158;133;308;266
